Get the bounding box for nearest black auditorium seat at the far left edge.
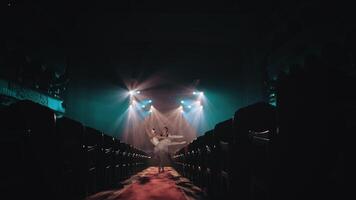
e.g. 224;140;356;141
1;100;60;199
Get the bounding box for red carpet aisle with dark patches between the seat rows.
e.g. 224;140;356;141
87;167;205;200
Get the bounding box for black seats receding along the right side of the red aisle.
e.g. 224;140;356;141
173;103;276;199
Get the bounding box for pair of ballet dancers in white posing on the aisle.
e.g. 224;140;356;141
148;126;186;173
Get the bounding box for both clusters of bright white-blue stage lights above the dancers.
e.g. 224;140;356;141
129;90;204;113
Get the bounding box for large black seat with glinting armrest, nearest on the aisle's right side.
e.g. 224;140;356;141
233;102;277;199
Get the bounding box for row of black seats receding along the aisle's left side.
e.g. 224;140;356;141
0;101;150;199
